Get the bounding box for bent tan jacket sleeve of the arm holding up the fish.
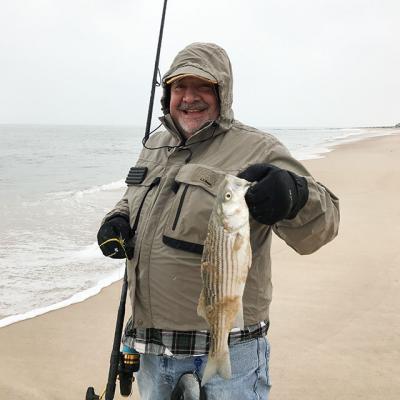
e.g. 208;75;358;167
268;142;340;254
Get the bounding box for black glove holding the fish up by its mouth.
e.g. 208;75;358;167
238;164;308;225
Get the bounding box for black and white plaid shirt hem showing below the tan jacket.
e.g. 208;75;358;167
122;319;269;357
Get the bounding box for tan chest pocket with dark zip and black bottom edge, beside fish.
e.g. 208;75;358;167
163;164;225;254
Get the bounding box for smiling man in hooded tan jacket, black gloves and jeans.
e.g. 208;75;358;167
98;43;339;400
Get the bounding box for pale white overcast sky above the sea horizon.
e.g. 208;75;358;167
0;0;400;127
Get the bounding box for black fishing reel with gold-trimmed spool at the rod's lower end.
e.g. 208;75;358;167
85;352;140;400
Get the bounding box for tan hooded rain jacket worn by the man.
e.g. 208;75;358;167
106;43;339;330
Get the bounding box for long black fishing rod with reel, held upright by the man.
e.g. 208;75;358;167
85;0;168;400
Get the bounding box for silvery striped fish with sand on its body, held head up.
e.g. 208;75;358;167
197;174;252;386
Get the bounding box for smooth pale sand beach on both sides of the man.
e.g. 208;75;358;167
0;135;400;400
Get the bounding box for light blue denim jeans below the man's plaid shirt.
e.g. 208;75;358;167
136;337;271;400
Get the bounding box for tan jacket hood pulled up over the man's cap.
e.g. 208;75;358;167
161;43;233;130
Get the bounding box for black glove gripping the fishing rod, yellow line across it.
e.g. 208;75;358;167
97;216;133;260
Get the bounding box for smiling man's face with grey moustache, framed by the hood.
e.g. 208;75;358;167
169;76;219;138
